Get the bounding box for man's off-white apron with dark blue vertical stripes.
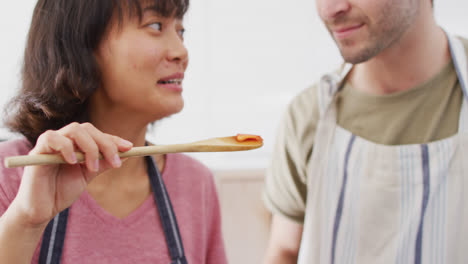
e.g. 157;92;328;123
298;34;468;264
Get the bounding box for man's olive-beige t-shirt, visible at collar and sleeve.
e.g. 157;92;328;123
263;37;468;223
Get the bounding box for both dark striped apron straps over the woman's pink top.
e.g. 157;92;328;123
39;156;187;264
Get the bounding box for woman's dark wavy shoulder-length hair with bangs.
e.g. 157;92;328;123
5;0;189;144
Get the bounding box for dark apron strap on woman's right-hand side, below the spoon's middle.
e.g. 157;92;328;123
145;156;187;264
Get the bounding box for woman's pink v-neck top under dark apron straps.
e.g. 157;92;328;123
0;139;227;264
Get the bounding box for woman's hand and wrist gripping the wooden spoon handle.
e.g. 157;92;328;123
12;123;132;227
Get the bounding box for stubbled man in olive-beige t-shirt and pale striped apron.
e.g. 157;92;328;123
264;0;468;264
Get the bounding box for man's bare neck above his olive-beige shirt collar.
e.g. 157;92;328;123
349;7;450;94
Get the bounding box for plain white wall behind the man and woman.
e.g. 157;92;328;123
0;0;468;169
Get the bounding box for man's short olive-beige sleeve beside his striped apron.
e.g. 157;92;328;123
263;86;319;223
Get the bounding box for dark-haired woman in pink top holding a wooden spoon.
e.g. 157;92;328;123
0;0;226;264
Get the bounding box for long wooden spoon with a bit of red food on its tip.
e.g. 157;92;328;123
4;136;263;168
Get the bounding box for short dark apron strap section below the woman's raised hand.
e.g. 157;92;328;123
38;208;69;264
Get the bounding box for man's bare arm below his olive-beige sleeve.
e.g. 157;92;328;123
263;214;302;264
